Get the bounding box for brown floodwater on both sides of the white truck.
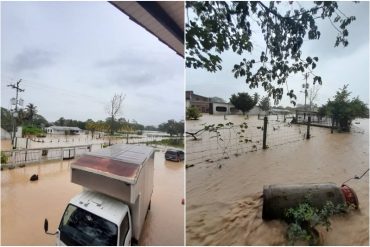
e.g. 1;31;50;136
1;149;185;245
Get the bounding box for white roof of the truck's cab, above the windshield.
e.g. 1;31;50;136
70;190;129;227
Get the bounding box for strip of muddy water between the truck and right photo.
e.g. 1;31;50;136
139;152;185;245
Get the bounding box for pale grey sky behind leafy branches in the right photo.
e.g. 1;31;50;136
186;2;369;106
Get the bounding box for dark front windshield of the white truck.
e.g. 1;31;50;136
59;204;117;246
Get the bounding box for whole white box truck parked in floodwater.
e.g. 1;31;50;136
44;144;154;245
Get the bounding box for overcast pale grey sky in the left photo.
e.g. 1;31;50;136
1;2;184;125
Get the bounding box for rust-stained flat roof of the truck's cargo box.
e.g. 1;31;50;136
71;144;153;184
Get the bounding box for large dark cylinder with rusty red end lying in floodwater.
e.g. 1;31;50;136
262;183;359;220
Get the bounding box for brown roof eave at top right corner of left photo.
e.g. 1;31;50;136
110;1;184;57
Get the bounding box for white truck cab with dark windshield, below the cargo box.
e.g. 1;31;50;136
57;191;132;246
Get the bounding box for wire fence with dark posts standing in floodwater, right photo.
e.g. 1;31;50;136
186;115;326;165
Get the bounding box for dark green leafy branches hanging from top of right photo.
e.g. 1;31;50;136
185;1;356;104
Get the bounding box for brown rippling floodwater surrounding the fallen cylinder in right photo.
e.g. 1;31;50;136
186;115;369;245
